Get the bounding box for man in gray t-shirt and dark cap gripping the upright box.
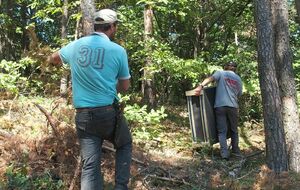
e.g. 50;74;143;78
195;61;243;159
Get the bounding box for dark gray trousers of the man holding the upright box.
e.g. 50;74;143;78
215;106;239;157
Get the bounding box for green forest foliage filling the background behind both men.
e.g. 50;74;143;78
0;0;300;121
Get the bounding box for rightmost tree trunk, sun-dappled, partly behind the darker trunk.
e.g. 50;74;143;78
271;0;300;172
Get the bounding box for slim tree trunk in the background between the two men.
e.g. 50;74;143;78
142;5;155;108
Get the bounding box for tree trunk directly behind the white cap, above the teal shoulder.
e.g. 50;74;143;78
80;0;95;36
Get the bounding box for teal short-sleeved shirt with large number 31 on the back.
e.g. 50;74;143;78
59;33;130;108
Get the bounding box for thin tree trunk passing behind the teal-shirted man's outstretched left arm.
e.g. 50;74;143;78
60;0;70;98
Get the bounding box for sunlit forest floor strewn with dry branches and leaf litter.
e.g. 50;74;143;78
0;98;300;190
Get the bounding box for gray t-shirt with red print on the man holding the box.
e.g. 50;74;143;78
212;70;243;108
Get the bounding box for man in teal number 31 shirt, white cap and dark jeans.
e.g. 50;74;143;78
48;9;132;190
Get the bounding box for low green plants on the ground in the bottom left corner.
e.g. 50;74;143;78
0;164;64;190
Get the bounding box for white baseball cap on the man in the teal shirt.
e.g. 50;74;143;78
94;9;119;24
